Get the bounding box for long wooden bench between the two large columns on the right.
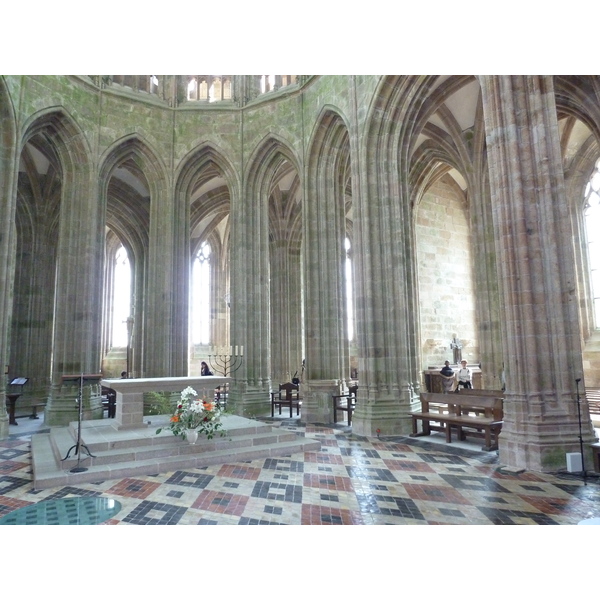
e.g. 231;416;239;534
411;390;504;451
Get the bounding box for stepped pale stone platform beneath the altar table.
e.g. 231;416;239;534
31;415;321;490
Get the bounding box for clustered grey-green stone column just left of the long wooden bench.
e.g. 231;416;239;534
352;78;428;436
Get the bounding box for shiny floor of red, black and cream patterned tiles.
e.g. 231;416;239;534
0;420;600;525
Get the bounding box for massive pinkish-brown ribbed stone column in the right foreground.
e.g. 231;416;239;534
480;76;594;471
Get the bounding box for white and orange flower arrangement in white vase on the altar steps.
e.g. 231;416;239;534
156;386;226;440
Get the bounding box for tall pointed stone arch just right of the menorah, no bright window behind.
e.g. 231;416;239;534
239;134;303;386
